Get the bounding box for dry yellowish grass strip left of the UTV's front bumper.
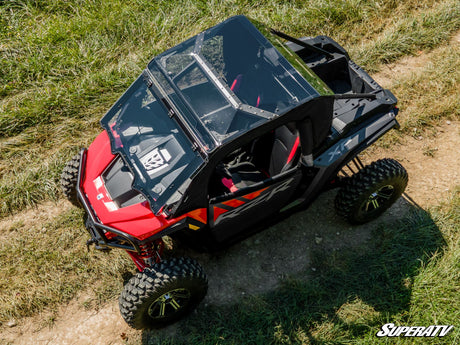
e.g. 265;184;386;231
0;206;132;322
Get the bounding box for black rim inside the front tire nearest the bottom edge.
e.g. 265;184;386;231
148;288;190;319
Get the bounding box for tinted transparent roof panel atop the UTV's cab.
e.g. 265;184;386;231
149;16;324;146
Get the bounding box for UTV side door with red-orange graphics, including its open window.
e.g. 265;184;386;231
208;124;302;242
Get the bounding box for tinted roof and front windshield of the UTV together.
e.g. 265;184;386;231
101;16;332;215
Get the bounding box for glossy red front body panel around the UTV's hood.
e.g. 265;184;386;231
82;131;207;240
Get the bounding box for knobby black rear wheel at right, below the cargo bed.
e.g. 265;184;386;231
335;158;408;224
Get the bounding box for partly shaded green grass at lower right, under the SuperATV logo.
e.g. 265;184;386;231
140;191;460;344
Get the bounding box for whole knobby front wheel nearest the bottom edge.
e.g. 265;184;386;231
119;258;208;329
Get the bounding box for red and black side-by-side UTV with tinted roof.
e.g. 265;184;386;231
61;16;408;328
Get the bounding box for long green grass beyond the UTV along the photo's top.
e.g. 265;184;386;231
0;0;460;217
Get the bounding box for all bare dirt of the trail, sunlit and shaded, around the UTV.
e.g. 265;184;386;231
0;34;460;345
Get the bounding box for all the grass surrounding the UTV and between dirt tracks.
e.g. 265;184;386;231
0;0;460;344
